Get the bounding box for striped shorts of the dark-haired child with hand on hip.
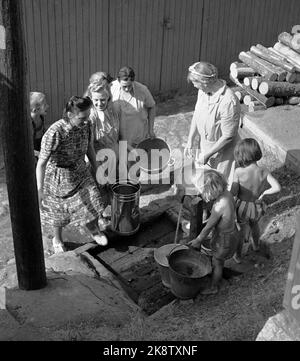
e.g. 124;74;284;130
236;199;267;223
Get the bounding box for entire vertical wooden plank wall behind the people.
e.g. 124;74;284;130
22;0;300;123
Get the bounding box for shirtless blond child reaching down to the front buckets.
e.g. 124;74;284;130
188;169;239;294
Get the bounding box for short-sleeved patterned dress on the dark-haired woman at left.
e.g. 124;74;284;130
39;119;104;227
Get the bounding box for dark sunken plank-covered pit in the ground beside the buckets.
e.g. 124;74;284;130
90;214;240;315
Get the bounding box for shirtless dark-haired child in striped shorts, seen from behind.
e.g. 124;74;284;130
231;138;280;263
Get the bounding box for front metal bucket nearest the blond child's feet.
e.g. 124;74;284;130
169;249;212;300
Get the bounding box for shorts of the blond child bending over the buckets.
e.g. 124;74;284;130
210;227;239;261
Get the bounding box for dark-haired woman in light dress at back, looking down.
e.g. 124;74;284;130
111;67;155;178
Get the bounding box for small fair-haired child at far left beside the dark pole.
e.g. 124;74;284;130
30;92;49;158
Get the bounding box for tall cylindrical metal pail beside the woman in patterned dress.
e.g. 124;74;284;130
111;181;141;236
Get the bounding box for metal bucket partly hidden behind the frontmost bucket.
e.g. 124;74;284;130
154;243;188;288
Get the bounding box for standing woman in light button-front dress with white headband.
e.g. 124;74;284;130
184;62;240;188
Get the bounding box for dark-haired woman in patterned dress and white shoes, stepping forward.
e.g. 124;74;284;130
36;96;107;252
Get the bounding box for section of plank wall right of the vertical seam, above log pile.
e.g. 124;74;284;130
200;0;300;79
